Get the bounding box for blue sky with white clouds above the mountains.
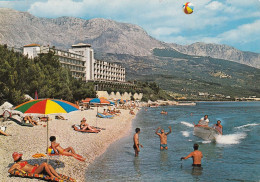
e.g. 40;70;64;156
0;0;260;53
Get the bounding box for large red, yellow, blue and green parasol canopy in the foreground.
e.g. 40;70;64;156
15;99;79;114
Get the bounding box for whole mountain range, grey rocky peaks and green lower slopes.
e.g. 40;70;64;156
0;8;260;96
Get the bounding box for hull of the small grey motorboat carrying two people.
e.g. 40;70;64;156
193;125;221;141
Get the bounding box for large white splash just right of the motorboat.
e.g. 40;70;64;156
216;133;247;145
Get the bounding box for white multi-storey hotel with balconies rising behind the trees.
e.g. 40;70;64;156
23;43;125;83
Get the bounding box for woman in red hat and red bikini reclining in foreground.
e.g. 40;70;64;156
8;152;61;179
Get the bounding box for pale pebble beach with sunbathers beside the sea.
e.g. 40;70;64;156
0;108;138;182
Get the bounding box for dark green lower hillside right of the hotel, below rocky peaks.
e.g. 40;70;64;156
96;49;260;98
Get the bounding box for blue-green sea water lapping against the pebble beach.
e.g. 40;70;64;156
85;102;260;182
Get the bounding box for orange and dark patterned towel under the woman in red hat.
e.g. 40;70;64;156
10;169;76;182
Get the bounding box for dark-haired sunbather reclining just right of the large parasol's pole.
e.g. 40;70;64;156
50;136;86;161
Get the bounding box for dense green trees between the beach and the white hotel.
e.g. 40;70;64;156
0;45;96;105
